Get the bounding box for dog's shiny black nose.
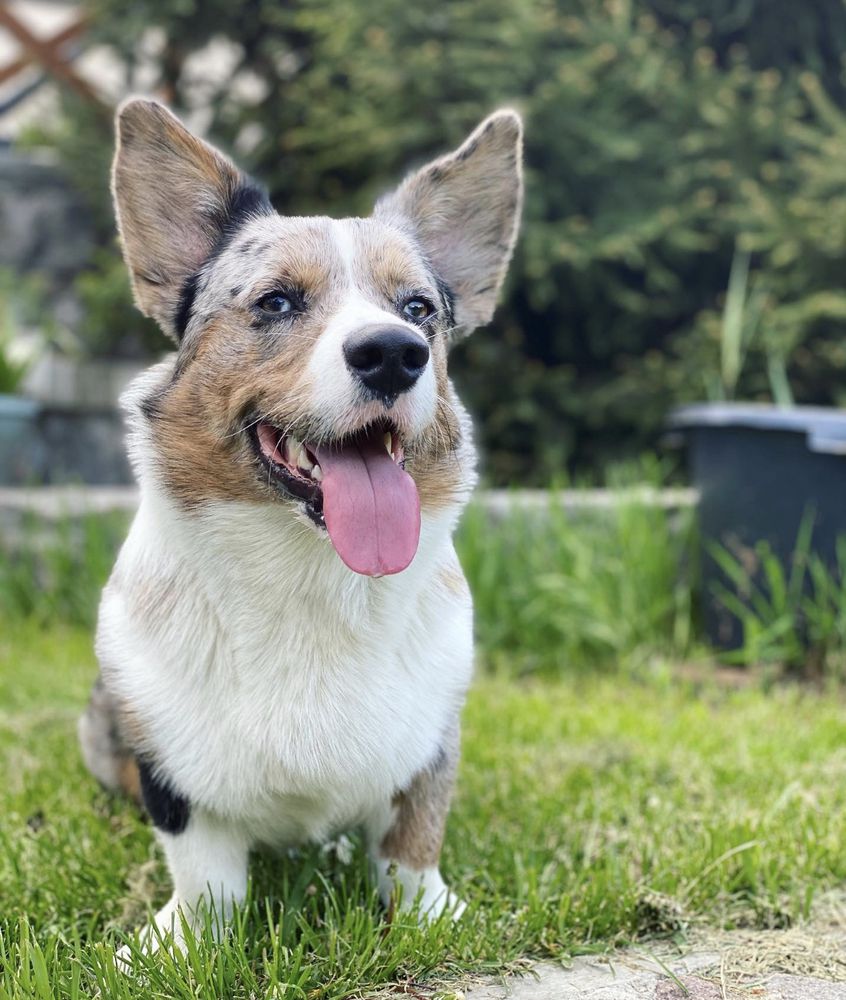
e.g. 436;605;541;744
344;326;429;402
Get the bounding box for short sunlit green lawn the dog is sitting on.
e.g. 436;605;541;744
0;622;846;1000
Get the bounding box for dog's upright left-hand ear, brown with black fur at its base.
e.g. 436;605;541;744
112;98;271;341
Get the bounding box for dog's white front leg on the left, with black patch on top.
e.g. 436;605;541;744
119;766;249;966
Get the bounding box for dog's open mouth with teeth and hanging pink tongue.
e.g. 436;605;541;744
250;420;420;576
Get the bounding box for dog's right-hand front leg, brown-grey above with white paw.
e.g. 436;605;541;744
366;723;465;920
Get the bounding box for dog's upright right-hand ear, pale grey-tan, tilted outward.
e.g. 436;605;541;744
376;110;523;333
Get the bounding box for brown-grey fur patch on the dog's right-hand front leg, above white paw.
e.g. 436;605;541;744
379;720;459;871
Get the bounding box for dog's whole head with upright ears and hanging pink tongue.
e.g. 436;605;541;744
113;100;521;575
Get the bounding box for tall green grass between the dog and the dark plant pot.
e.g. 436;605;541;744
458;491;695;673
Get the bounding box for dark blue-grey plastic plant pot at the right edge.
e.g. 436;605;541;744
669;403;846;650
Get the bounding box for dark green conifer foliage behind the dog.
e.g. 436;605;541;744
39;0;846;482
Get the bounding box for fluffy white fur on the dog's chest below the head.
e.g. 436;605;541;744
98;493;472;842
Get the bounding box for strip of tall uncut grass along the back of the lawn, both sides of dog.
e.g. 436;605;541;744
0;500;846;679
